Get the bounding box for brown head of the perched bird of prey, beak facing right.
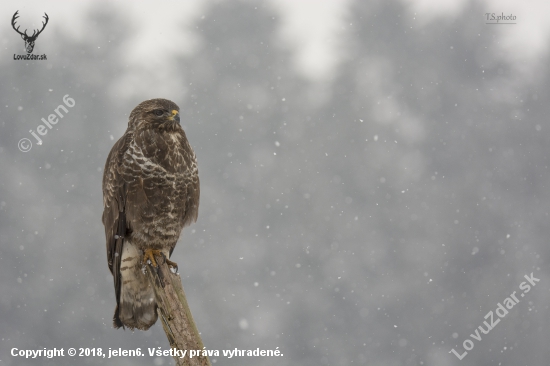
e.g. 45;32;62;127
128;99;181;131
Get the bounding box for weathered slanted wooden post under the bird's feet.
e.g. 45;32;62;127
147;255;211;366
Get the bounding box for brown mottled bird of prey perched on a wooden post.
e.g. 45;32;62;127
102;99;200;330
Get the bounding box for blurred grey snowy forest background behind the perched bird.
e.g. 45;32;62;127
0;0;550;366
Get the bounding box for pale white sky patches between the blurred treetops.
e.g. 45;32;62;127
2;0;550;85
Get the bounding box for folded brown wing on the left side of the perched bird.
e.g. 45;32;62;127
102;133;132;326
